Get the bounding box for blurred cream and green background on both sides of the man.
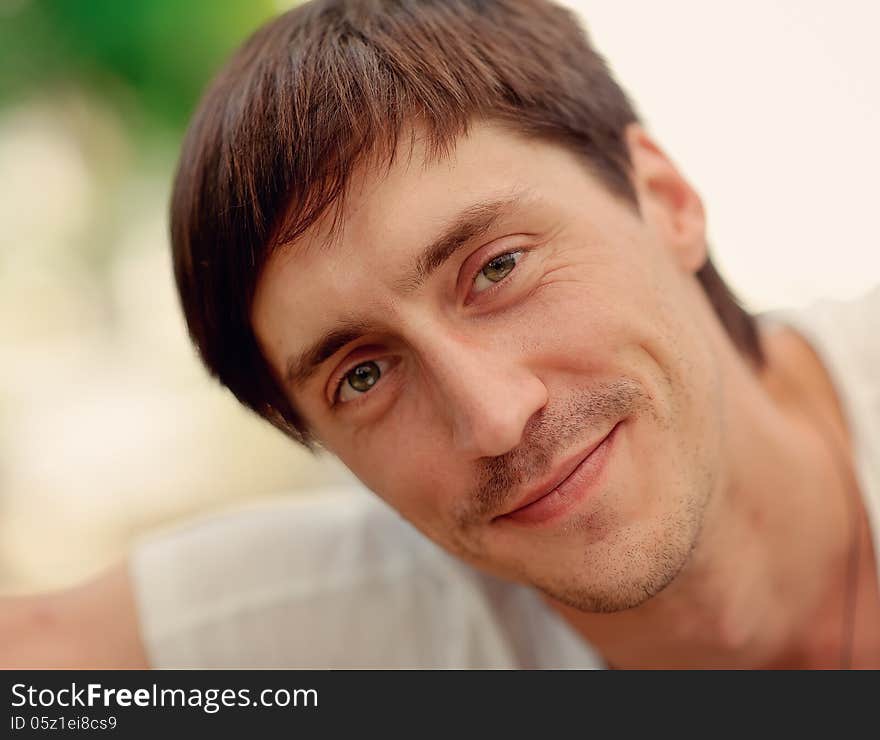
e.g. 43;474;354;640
0;0;880;592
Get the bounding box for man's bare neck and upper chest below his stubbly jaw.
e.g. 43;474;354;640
549;316;880;668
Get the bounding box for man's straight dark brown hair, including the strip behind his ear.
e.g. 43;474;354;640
171;0;763;449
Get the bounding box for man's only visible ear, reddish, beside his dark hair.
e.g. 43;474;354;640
626;123;708;273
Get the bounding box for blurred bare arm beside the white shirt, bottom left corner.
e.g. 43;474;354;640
0;561;150;669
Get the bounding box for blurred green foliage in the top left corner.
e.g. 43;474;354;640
0;0;282;133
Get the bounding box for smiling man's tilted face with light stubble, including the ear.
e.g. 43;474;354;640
252;118;721;611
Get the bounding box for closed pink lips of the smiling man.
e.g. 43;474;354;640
492;421;623;525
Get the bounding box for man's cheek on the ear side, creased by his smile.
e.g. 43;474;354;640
528;243;718;444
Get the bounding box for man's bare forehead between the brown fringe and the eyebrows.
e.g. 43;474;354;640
252;123;600;396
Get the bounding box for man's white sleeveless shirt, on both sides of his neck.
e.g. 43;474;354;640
130;287;880;668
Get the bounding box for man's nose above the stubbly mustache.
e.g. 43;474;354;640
410;332;548;458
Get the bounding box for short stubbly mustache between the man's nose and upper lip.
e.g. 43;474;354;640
457;378;648;527
